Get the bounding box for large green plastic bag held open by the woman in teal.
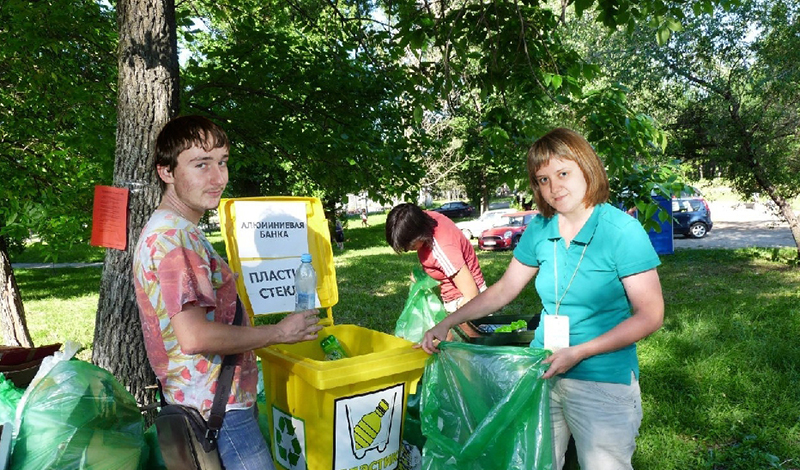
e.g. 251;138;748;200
421;342;553;470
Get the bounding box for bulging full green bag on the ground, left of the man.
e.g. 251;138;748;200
9;360;150;470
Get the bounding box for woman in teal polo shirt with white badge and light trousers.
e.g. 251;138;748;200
421;128;664;470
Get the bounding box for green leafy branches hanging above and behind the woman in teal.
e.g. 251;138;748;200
388;0;724;219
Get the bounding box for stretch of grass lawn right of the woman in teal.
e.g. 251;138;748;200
634;250;800;470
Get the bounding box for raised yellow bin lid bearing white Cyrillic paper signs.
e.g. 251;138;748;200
219;197;338;323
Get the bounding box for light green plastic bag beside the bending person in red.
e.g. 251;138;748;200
394;266;447;343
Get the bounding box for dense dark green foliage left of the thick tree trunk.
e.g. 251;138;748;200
0;0;116;260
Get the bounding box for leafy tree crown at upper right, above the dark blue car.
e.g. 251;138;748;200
602;0;800;207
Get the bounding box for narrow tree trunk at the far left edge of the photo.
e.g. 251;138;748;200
0;237;33;347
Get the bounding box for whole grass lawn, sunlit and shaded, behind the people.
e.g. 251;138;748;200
14;221;800;470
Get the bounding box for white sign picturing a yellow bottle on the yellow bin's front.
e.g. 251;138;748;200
333;382;405;470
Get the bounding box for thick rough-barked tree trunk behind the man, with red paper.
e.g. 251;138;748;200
92;0;178;410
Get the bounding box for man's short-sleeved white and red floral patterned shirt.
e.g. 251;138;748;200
133;210;258;419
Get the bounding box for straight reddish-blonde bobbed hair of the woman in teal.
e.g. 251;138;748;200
528;127;609;217
